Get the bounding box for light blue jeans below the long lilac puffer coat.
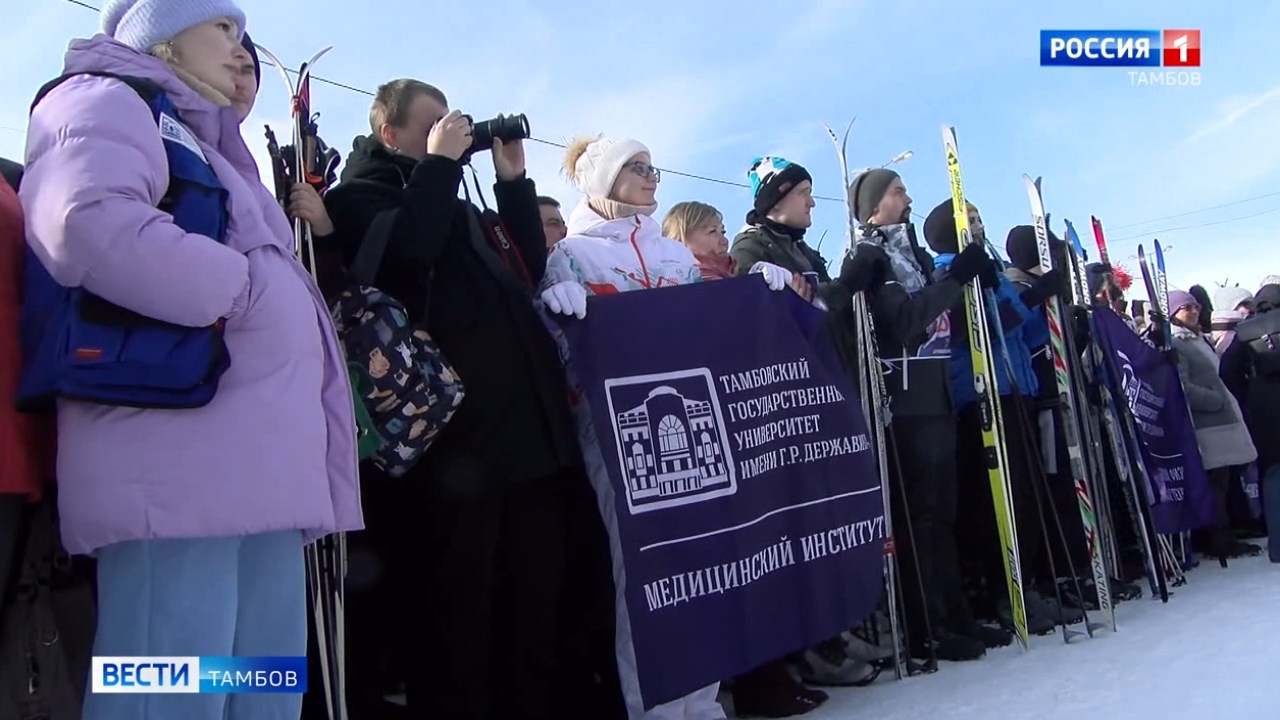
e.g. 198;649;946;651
83;530;307;720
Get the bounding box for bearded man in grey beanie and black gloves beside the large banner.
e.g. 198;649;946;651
849;169;1012;660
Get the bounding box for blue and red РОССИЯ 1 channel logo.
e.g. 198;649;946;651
1041;29;1201;68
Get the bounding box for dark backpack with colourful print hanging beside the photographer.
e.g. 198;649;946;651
330;211;466;478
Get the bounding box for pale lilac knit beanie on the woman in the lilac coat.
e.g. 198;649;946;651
101;0;244;53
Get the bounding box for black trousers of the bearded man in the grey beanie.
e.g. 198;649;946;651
890;415;973;635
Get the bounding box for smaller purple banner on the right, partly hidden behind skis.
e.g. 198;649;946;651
1094;309;1215;533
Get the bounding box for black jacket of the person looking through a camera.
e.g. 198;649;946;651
325;137;582;482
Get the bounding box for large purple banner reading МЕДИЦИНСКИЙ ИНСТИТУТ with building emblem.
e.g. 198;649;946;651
562;277;884;708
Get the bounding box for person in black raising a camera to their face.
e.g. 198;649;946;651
325;79;582;720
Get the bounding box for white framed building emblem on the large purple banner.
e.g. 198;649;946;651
604;368;737;515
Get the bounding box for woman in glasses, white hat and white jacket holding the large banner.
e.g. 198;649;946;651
543;137;791;720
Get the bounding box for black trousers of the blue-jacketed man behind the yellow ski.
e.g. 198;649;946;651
956;396;1044;600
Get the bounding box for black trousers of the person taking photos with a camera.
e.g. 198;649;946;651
390;456;568;720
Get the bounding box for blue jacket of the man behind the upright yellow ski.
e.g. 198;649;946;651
934;254;1048;411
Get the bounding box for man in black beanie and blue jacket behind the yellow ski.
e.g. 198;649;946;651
924;199;1080;634
